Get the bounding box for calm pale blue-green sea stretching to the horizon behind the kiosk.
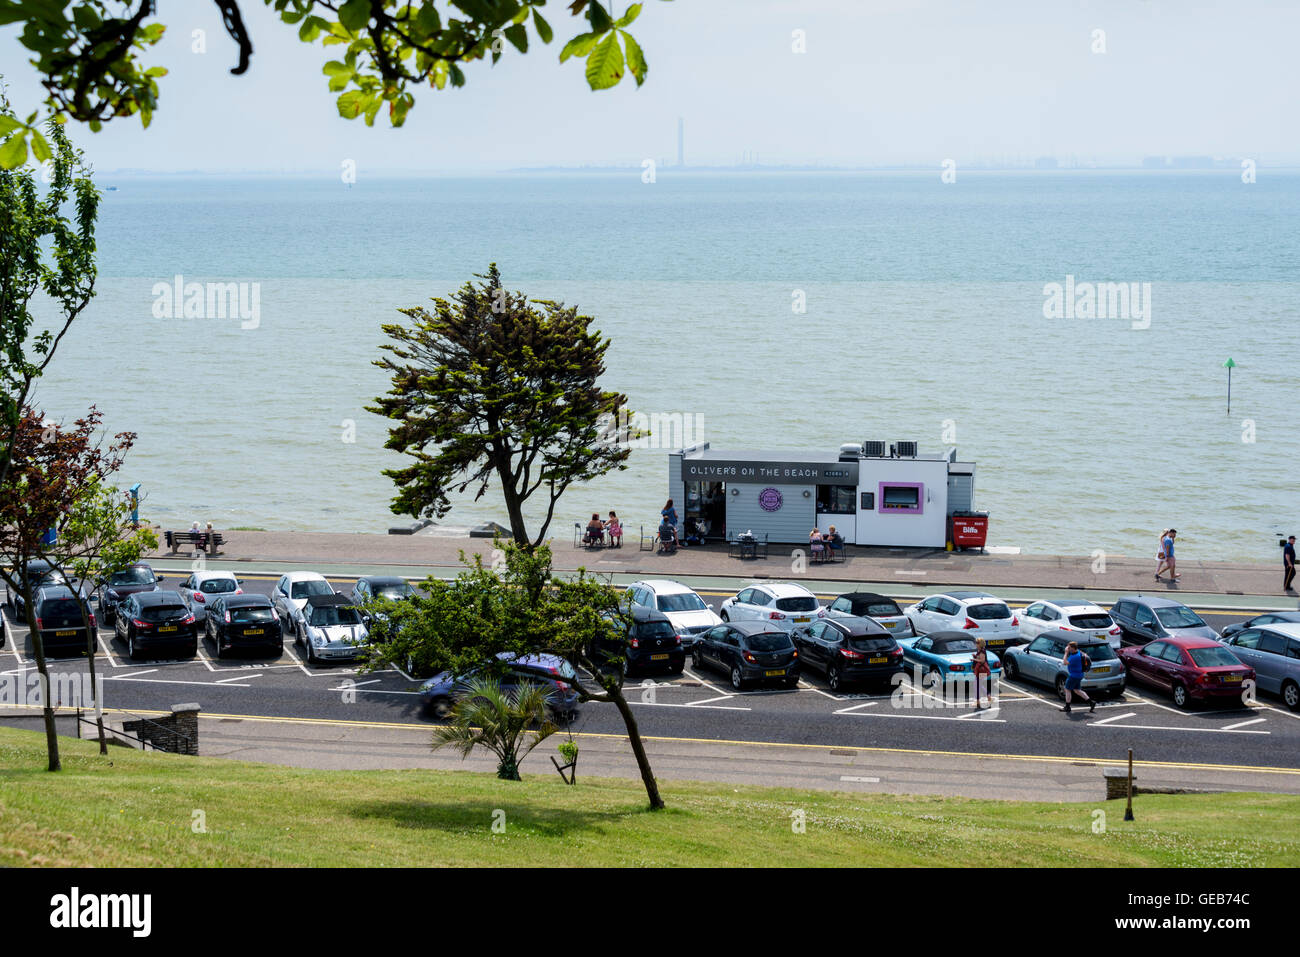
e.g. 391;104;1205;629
27;170;1300;560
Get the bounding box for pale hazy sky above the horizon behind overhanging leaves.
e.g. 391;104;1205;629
0;0;1300;173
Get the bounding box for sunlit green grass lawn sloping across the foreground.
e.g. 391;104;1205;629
0;728;1300;867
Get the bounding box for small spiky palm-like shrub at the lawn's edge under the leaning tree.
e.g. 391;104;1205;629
433;679;558;781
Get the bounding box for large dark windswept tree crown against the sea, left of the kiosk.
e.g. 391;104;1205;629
369;263;640;547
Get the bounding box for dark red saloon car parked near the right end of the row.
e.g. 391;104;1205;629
1118;638;1255;707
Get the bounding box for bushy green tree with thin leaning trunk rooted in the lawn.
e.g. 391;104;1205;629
365;541;664;810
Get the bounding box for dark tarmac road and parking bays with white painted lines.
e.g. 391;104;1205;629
0;575;1300;768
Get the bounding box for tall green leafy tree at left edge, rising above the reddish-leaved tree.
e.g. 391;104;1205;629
0;91;99;488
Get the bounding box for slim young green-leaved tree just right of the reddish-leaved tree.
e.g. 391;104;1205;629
39;475;159;754
